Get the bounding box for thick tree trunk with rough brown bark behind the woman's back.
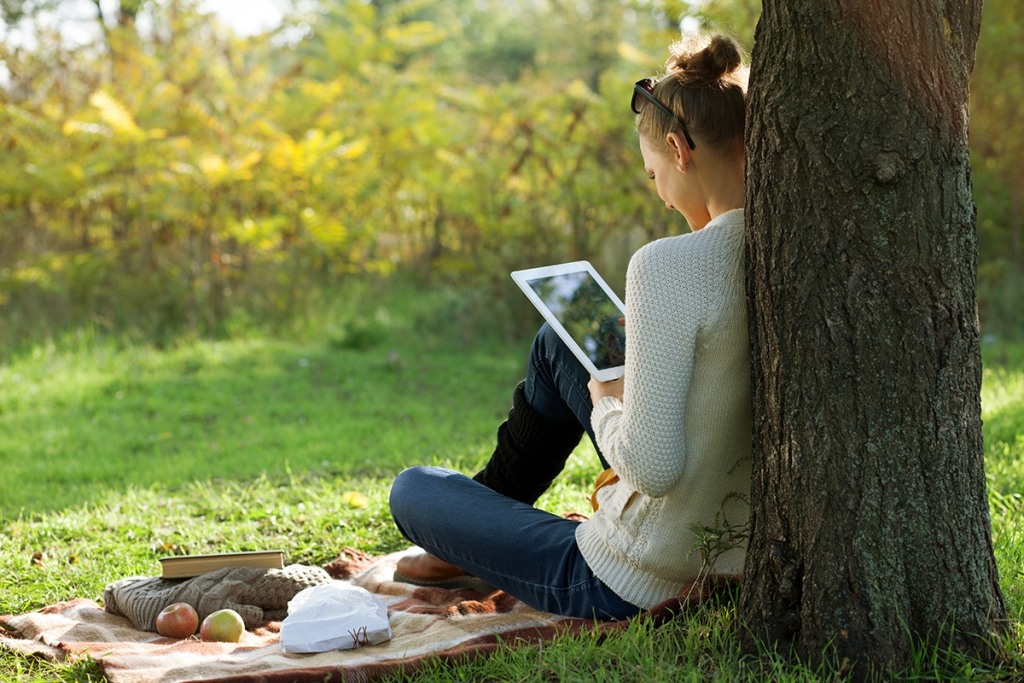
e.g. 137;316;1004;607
741;0;1006;678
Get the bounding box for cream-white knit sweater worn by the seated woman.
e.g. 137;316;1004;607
575;210;751;608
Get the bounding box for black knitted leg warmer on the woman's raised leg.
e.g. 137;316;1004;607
473;382;584;505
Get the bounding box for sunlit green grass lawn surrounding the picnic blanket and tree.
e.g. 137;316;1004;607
0;297;1024;682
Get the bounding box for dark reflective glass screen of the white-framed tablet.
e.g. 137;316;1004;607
526;270;626;370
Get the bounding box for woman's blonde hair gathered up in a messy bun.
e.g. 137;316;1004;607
637;34;748;153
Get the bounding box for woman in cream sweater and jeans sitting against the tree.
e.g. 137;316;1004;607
391;31;751;618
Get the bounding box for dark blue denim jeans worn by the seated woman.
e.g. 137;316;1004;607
391;325;641;620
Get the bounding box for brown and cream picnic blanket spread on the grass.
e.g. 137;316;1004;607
0;549;738;683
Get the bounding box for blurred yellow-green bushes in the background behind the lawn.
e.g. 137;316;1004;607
0;0;1024;357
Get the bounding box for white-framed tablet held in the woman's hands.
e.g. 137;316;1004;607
512;261;626;382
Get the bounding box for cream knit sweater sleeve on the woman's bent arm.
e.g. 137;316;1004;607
591;233;714;498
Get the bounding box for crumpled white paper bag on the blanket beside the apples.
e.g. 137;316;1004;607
281;583;391;653
